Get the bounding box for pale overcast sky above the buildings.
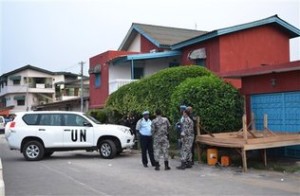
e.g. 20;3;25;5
0;0;300;74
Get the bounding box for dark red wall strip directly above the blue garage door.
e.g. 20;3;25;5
241;70;300;120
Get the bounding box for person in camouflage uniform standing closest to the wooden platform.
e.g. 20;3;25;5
177;110;194;169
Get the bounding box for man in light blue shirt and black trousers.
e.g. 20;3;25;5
136;111;155;167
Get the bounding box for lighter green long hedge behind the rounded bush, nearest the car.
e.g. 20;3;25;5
106;66;212;118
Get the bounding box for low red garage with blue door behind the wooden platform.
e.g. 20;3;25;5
222;61;300;158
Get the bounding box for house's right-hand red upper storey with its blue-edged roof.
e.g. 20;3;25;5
172;15;300;88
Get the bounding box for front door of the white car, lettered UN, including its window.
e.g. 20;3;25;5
64;114;94;147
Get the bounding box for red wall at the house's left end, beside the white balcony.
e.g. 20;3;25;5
90;51;136;108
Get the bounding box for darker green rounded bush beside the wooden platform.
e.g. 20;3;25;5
171;75;243;133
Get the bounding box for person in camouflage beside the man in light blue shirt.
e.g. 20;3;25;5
151;109;171;171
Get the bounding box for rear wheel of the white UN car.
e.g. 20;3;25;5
23;141;45;161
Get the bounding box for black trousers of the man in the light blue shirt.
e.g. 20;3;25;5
140;135;155;166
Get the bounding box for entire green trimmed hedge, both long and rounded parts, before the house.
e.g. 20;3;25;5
101;66;243;132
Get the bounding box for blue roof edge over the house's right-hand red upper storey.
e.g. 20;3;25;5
171;15;300;50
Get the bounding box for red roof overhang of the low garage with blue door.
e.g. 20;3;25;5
219;61;300;78
